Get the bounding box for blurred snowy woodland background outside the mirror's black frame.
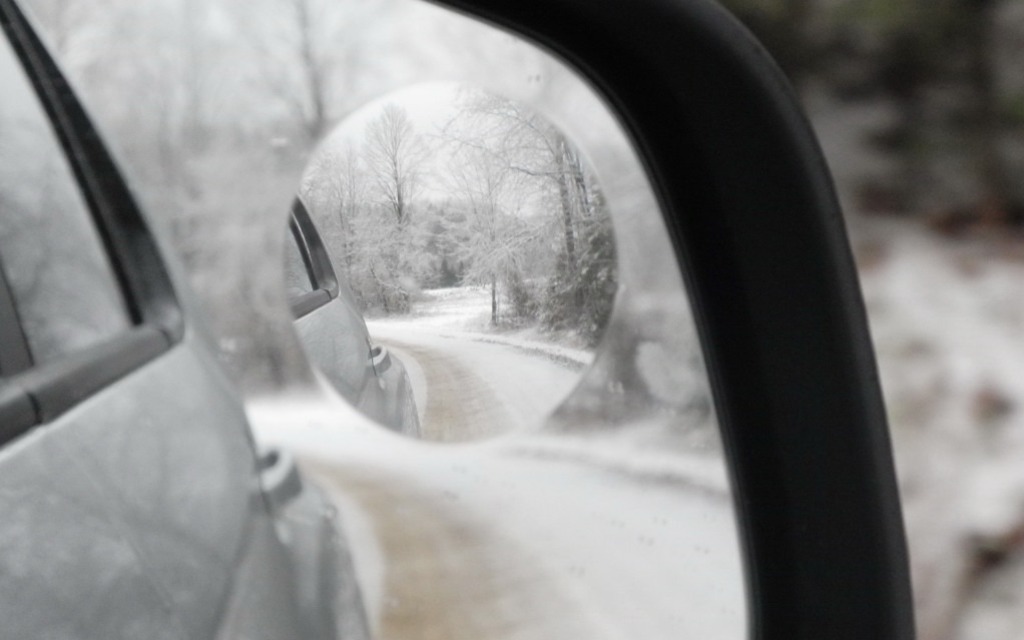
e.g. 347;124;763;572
723;0;1024;640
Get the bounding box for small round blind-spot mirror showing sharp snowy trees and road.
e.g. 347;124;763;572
287;85;616;441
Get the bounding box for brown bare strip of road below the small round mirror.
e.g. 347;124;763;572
310;454;603;640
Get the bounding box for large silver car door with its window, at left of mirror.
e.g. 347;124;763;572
0;0;294;639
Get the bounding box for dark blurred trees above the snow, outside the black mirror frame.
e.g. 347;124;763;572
724;0;1024;227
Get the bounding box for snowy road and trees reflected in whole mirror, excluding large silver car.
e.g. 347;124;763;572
22;0;745;640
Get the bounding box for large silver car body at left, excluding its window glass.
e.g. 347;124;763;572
0;0;367;640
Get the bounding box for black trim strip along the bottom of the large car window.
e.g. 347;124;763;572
0;327;171;444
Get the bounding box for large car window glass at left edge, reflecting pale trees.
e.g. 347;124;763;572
0;33;131;364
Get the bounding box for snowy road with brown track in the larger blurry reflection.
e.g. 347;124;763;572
251;399;745;640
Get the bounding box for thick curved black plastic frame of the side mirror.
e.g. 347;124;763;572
428;0;914;640
